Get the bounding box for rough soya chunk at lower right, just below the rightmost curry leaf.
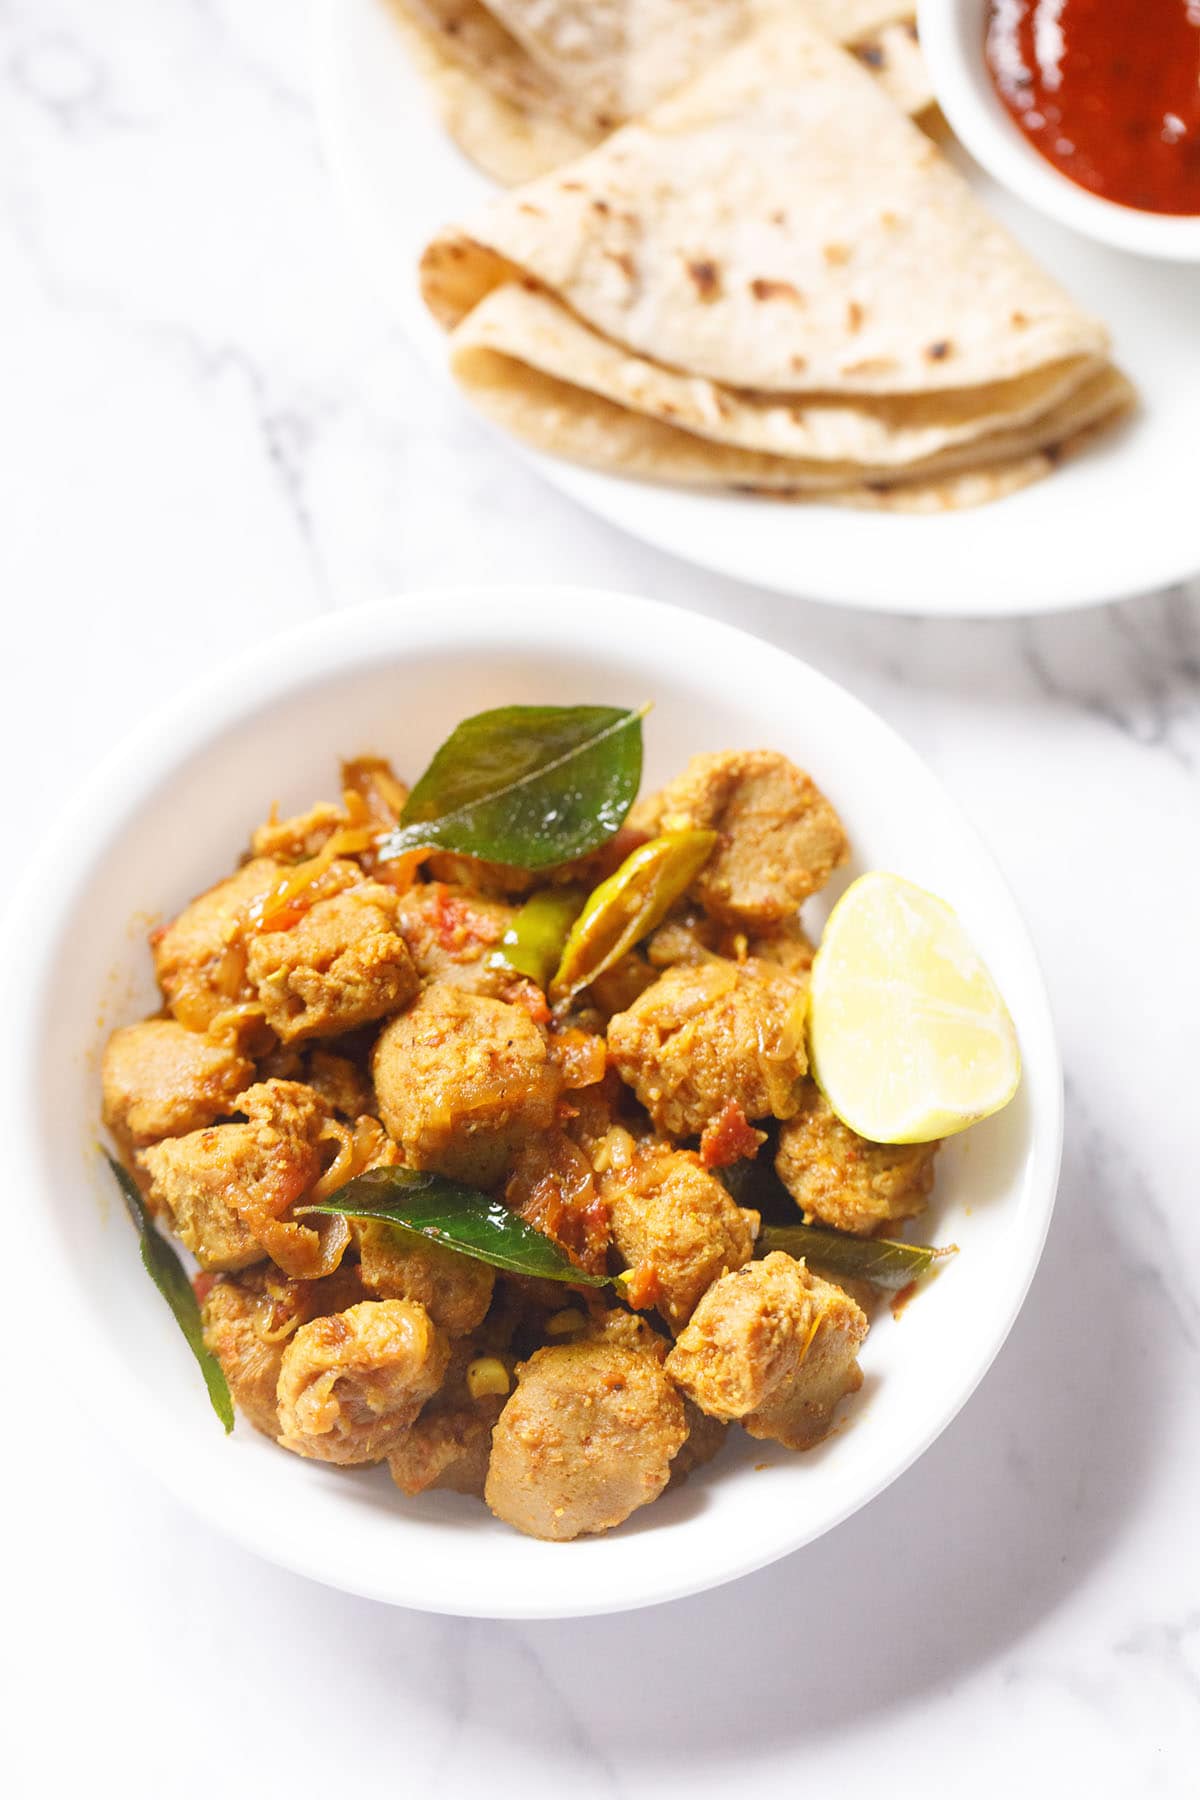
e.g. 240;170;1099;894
667;1251;867;1451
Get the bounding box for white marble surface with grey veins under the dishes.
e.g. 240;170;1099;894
0;0;1200;1800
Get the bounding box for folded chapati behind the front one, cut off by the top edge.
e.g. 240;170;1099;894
394;0;932;182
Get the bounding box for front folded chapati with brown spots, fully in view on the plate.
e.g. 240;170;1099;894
421;11;1132;509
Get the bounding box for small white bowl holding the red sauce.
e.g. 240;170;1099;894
918;0;1200;263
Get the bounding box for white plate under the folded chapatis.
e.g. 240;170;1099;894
313;0;1200;616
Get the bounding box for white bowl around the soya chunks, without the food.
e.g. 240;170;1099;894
4;589;1061;1618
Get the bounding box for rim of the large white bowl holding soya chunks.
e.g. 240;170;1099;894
4;583;1063;1618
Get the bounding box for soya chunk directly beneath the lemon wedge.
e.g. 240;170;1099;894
775;1084;937;1237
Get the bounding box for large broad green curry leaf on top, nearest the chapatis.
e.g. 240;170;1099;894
378;706;646;869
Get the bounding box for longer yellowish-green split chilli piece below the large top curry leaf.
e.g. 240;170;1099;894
551;832;716;1001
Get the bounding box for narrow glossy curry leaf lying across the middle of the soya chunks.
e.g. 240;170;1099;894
297;1168;608;1287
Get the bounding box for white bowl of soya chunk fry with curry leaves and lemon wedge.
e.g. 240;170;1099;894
5;589;1061;1618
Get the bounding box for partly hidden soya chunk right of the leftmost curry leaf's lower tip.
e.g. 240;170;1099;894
200;1265;365;1438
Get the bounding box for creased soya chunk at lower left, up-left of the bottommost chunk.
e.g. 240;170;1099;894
277;1300;450;1463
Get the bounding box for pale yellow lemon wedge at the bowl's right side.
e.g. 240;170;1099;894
808;873;1020;1143
